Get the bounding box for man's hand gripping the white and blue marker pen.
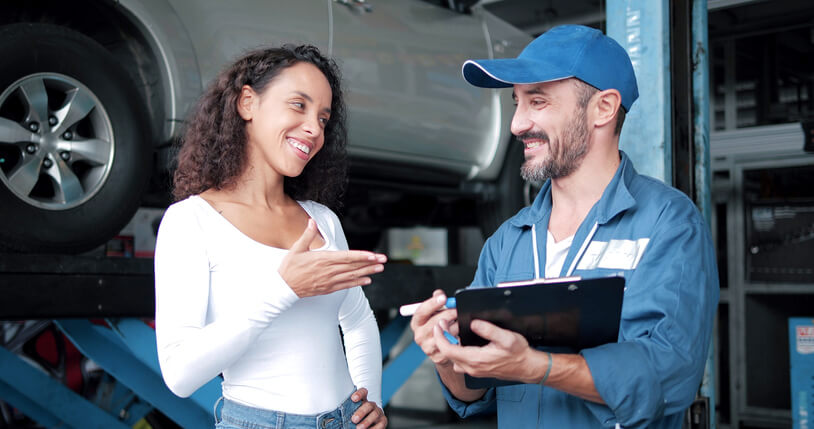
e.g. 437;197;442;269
410;289;458;365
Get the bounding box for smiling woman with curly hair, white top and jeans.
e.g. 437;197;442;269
155;46;387;429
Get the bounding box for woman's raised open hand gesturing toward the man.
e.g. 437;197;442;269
277;219;387;298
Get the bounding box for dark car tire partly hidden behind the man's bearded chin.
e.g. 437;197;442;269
477;139;540;238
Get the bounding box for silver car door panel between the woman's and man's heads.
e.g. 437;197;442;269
333;0;494;171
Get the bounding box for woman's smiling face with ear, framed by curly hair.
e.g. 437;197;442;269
238;62;332;177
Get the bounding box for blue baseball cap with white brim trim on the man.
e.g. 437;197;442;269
462;25;639;111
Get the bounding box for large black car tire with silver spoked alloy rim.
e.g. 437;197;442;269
0;24;152;253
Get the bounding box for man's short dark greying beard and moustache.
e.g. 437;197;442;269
518;107;588;183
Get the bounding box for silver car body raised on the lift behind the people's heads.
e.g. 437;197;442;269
119;0;530;180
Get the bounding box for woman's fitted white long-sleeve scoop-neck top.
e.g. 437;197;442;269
155;196;382;414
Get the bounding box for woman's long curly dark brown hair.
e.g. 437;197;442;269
173;45;347;209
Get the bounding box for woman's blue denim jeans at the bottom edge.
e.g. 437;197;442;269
215;395;362;429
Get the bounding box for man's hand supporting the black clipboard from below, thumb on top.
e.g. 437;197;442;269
433;320;547;383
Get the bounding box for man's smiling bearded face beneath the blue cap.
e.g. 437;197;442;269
512;79;589;182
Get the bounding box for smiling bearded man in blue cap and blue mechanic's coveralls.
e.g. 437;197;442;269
411;25;719;428
